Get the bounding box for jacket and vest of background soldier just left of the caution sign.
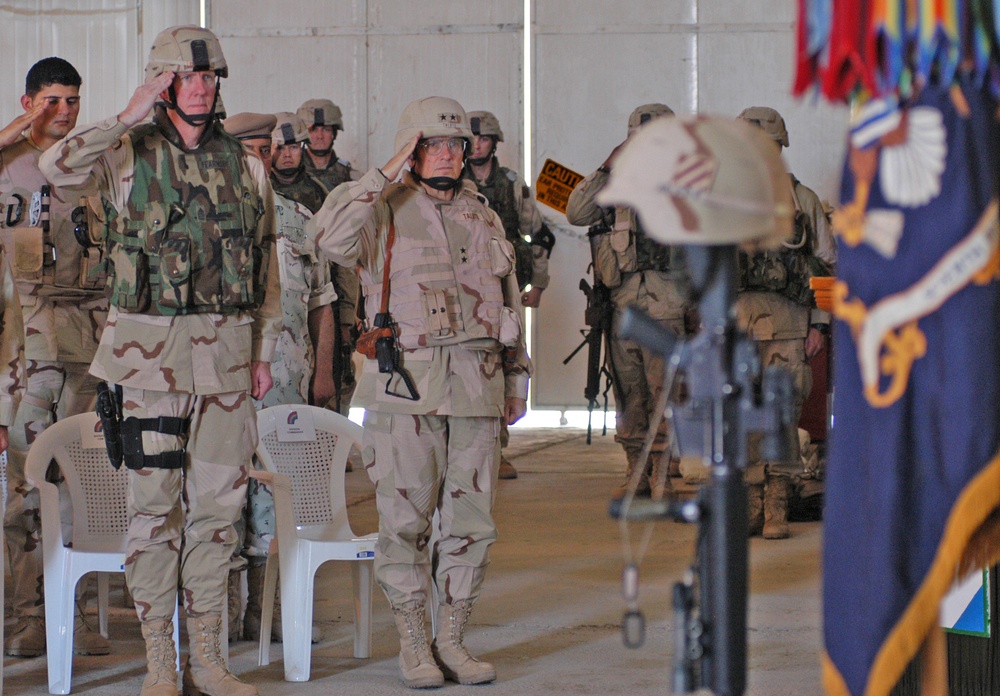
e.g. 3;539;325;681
465;157;549;289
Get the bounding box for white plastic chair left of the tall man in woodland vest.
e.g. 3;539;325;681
25;413;179;694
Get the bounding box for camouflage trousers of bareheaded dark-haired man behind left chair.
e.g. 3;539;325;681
4;360;97;617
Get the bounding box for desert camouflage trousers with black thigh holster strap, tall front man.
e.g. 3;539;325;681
122;387;257;621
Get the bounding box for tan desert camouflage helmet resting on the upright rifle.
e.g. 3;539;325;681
597;116;794;247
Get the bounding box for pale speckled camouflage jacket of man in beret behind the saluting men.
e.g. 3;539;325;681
258;194;337;408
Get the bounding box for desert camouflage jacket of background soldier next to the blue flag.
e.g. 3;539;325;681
736;175;837;341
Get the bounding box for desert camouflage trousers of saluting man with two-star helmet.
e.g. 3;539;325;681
362;410;500;607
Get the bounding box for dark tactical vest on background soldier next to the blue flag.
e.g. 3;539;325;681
739;178;832;307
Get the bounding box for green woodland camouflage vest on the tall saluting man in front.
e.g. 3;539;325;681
105;124;271;315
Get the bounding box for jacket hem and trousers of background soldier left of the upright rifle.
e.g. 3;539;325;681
611;271;684;462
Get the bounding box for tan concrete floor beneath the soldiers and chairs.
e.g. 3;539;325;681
4;428;822;696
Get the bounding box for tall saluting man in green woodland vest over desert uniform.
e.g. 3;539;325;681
41;26;281;696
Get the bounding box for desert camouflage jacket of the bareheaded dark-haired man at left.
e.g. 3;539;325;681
0;136;108;363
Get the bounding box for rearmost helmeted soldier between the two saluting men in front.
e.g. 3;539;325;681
296;99;358;418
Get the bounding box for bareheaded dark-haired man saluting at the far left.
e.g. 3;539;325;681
0;58;111;657
